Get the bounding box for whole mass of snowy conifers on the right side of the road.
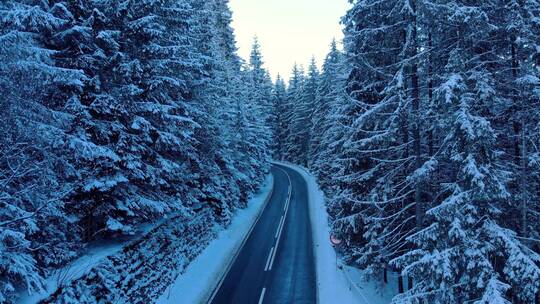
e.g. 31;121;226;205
276;0;540;304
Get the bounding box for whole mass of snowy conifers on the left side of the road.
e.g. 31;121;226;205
0;0;272;303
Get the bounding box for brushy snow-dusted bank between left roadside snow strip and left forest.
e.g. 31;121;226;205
31;177;272;303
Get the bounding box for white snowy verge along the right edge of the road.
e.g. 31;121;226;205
276;162;397;304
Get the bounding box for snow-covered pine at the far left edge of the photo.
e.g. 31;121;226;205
0;1;83;303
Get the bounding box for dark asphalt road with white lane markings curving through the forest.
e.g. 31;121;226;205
210;165;316;304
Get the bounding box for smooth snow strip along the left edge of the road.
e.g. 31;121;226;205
156;175;274;304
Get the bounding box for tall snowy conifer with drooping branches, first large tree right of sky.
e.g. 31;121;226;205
332;0;418;274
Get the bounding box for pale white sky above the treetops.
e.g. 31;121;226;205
230;0;349;79
